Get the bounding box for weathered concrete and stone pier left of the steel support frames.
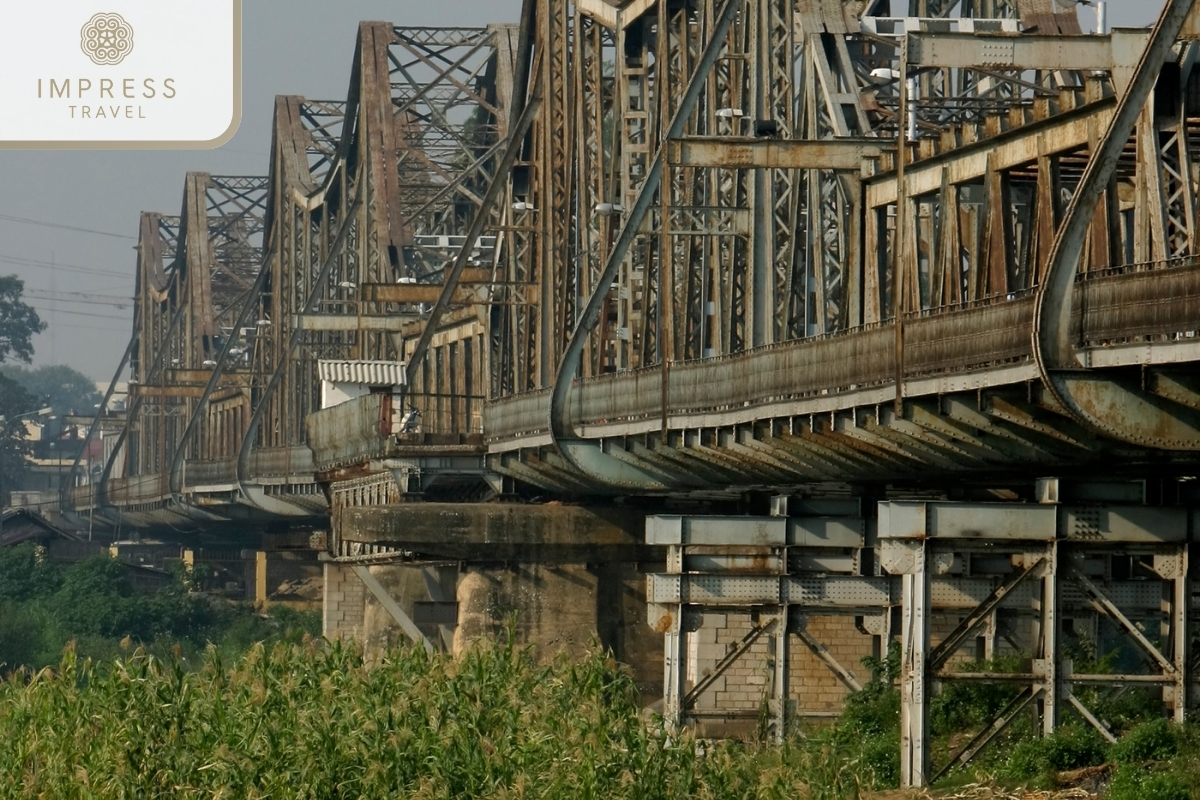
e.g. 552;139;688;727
324;503;665;702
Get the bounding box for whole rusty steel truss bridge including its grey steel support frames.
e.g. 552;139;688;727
51;0;1200;784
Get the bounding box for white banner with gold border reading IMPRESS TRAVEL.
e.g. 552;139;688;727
0;0;241;149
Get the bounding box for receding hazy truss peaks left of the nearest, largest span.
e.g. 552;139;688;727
72;23;516;513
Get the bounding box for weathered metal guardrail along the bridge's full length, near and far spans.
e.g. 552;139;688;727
77;266;1200;509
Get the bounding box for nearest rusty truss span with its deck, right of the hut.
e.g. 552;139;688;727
475;1;1200;492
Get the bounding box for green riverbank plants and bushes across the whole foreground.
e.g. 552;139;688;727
0;546;1200;800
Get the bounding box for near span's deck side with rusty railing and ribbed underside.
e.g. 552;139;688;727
484;259;1200;488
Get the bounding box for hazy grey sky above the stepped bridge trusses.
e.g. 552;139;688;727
0;0;1162;381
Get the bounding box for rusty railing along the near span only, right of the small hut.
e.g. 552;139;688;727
484;259;1200;444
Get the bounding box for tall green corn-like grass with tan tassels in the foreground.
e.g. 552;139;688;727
0;640;897;800
